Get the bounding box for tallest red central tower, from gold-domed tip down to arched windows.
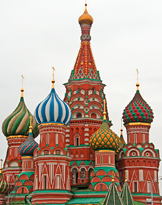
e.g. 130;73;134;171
64;4;111;186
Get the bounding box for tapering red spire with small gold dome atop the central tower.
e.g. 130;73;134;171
69;3;101;81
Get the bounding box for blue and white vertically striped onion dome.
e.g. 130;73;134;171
34;88;71;125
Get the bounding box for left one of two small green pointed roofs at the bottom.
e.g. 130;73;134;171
103;182;124;205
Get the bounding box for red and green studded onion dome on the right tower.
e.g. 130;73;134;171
123;90;154;125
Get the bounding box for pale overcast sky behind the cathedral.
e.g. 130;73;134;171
0;0;162;194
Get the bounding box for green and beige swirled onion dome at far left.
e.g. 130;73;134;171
2;89;39;137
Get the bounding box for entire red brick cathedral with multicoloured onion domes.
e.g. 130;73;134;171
0;4;161;205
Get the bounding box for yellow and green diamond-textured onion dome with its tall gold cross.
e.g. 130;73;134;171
89;100;121;151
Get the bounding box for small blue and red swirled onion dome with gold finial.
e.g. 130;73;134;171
19;117;38;156
